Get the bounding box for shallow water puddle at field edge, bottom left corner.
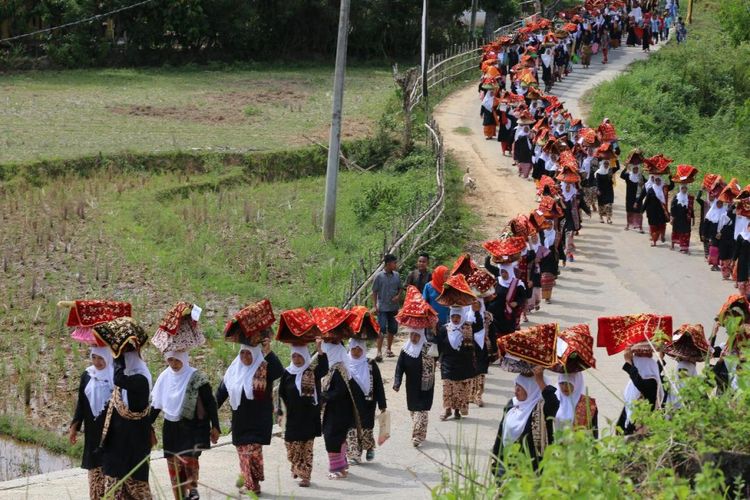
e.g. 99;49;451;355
0;436;73;481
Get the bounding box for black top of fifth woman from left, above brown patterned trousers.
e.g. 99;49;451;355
279;368;322;441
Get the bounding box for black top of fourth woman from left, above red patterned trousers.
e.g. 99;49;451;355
216;352;284;446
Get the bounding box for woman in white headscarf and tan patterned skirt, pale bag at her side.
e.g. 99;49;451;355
346;339;386;464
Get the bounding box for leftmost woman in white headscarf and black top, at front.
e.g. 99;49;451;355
69;347;115;500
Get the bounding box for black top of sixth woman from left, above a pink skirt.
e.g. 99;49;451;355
315;354;356;453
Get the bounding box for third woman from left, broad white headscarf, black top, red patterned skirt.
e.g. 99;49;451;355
151;351;221;500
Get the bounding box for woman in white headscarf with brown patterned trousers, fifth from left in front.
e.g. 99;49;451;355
277;345;320;487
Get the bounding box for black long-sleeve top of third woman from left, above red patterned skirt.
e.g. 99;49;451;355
151;371;221;457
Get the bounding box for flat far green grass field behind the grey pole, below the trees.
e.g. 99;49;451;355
0;64;395;164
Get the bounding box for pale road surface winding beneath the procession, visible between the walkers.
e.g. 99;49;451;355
0;42;732;499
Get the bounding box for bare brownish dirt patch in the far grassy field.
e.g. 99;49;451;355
107;89;309;124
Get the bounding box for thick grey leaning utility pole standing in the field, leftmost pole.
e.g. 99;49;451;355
323;0;350;241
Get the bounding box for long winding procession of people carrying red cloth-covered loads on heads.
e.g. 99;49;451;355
61;0;750;499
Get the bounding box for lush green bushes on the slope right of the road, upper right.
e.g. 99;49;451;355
589;1;750;183
